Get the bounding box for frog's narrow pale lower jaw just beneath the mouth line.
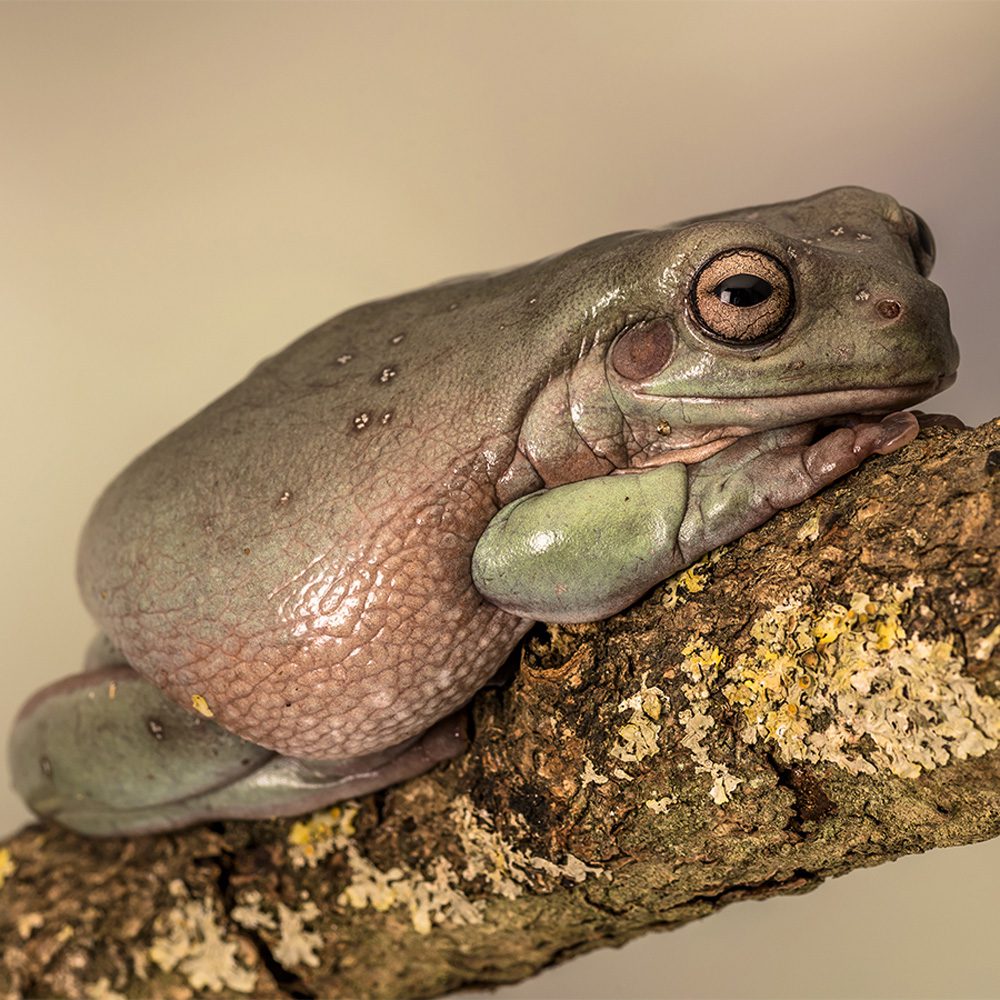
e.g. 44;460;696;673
643;374;955;426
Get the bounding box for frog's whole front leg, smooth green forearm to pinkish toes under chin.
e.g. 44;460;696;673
472;413;918;622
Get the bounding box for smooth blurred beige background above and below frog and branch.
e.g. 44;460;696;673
0;2;1000;998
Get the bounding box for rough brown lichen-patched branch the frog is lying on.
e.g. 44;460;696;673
0;421;1000;998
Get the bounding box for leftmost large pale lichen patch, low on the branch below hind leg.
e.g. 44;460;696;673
149;879;257;993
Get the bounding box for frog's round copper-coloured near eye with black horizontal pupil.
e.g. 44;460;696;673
691;247;795;344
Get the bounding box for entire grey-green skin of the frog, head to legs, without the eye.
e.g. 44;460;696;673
11;188;958;835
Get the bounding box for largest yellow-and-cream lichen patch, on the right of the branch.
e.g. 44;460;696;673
723;577;1000;778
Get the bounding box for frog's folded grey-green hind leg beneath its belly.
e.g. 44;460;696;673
10;665;468;836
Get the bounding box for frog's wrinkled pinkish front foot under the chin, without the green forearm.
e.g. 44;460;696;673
677;413;920;565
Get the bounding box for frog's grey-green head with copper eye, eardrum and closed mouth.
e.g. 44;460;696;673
607;187;958;463
